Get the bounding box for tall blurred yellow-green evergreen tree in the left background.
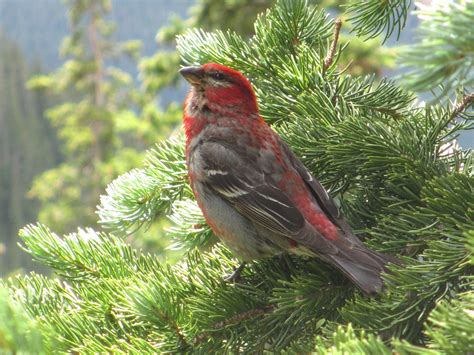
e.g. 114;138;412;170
29;0;147;232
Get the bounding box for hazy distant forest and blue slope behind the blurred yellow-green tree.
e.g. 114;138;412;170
0;0;194;276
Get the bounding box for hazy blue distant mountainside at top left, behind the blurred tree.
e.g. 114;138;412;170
0;0;195;71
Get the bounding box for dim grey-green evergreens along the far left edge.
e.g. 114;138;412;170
0;33;60;275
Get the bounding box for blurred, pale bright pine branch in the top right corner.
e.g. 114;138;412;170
399;1;474;103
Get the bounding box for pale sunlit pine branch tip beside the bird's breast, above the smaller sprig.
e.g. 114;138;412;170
97;138;191;234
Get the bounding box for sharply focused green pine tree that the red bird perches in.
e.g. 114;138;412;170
0;0;474;354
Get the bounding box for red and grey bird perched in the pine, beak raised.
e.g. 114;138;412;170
179;63;398;295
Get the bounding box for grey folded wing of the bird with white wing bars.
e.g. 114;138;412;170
196;142;305;237
